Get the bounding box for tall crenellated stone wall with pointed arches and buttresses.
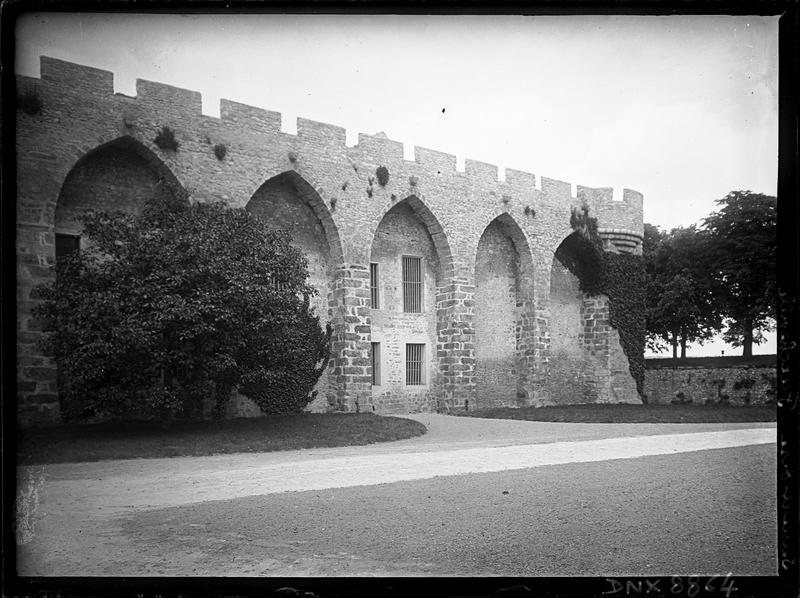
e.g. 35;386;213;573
16;57;642;424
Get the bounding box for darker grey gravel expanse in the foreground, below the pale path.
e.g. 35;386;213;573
112;445;777;577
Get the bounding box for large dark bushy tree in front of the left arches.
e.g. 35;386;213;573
37;200;331;418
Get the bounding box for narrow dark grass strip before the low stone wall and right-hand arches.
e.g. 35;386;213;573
456;404;776;424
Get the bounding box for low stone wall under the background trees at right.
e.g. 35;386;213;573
644;355;777;405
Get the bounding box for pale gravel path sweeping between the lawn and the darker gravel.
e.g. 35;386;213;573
17;414;775;575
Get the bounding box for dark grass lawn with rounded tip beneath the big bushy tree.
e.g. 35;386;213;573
17;413;427;465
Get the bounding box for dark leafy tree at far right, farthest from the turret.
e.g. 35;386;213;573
703;191;778;357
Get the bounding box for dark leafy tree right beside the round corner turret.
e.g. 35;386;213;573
642;224;722;357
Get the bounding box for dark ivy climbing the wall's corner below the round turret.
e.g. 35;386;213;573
557;205;646;402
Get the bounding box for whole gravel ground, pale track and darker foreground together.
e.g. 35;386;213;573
17;414;775;575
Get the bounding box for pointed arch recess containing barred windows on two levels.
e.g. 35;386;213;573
368;195;454;412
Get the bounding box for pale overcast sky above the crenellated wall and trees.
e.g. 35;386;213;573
16;13;778;354
